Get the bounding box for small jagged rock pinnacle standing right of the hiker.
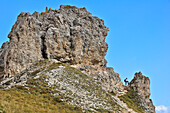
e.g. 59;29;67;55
129;72;155;113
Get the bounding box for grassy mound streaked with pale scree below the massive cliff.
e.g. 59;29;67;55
0;60;123;113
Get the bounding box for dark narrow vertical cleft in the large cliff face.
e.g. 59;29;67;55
41;36;48;59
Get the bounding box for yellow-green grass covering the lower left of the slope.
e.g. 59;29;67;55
0;61;82;113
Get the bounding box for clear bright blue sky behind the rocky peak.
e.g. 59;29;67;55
0;0;170;112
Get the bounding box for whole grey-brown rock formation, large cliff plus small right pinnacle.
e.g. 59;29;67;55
0;5;154;113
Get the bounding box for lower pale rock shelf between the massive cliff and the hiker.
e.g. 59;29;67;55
74;65;124;93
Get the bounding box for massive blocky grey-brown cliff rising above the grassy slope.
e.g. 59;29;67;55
0;6;108;76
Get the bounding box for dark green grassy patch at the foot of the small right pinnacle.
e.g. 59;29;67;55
119;89;144;113
